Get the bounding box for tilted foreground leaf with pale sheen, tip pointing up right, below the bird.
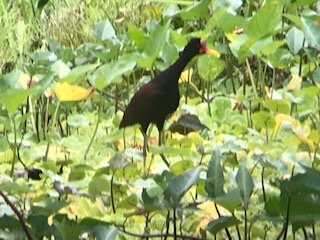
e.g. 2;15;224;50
164;168;200;207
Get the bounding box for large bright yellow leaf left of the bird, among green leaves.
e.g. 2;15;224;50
53;82;94;102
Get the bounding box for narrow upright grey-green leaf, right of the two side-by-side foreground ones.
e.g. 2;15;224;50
236;164;253;210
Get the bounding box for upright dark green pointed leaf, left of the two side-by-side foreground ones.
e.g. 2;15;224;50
205;148;225;198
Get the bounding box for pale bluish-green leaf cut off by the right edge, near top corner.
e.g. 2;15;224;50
301;17;320;50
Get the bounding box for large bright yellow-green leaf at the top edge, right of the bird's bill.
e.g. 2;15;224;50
246;1;282;39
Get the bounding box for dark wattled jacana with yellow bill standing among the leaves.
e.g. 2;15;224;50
120;38;219;165
